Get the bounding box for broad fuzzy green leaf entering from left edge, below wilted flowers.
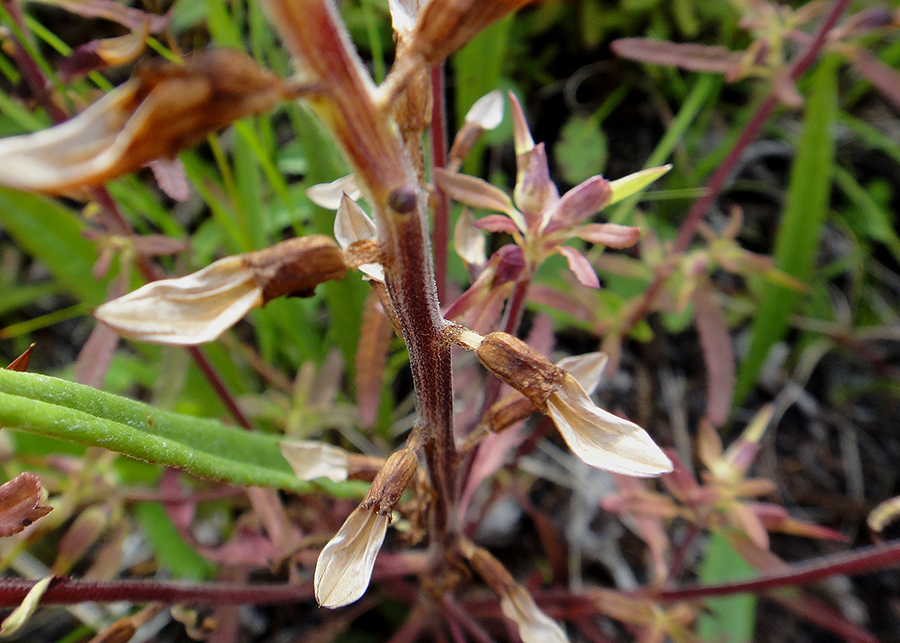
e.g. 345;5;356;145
0;370;365;498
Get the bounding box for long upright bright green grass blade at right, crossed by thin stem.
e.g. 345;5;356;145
735;56;839;405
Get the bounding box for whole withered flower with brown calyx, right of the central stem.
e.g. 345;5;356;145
457;331;672;476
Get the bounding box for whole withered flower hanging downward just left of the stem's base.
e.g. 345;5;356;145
314;448;417;608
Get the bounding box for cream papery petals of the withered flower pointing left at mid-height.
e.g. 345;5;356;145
94;256;262;345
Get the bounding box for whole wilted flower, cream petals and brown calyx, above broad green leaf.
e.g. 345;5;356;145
94;235;346;345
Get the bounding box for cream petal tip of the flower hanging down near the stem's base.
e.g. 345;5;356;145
315;507;389;608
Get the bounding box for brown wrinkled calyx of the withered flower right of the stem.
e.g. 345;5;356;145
475;332;566;410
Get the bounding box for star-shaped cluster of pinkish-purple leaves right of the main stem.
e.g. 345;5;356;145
434;94;669;288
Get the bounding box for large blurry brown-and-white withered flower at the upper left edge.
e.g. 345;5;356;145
0;49;284;194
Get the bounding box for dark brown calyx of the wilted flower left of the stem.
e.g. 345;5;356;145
244;234;347;305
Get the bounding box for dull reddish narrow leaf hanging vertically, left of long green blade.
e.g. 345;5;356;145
694;285;734;426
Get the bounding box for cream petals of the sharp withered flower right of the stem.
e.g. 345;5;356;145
547;375;672;477
